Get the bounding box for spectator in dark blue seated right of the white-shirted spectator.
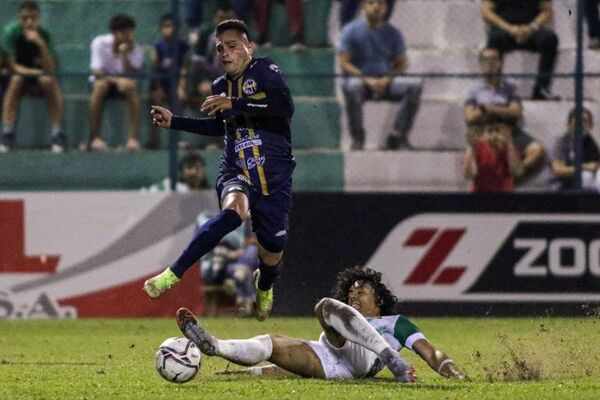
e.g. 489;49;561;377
145;14;189;149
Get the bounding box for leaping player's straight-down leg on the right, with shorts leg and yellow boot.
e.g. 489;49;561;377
251;186;292;321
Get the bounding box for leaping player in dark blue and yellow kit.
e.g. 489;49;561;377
144;20;296;320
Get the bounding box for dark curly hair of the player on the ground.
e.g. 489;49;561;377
331;267;398;315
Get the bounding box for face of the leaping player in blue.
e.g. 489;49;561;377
217;30;254;77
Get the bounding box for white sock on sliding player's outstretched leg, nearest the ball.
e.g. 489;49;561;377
217;335;273;366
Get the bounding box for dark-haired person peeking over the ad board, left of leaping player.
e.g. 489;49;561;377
142;152;209;193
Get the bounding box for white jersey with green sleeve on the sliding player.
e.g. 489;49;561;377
367;315;426;351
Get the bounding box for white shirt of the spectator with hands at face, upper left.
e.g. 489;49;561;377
90;33;144;75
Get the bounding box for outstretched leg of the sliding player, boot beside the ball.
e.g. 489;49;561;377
177;308;325;378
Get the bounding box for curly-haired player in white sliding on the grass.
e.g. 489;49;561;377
177;267;465;382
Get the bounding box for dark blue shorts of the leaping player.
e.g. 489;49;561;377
217;174;292;253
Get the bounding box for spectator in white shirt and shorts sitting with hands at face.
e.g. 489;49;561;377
89;14;144;151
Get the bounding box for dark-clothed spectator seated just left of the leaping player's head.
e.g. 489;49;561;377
178;2;237;111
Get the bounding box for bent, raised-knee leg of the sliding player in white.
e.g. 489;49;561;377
315;298;414;382
